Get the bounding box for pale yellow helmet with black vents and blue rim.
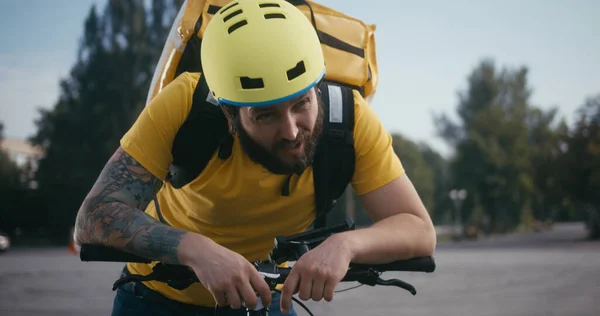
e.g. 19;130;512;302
200;0;325;106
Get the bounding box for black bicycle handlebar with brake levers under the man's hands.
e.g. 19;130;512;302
80;220;436;316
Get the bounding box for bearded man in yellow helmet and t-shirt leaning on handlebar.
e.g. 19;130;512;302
76;0;436;315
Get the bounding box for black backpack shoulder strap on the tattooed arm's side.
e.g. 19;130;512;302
167;76;233;189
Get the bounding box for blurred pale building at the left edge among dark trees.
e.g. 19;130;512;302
0;138;43;189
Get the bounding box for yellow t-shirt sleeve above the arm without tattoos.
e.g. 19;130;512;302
352;91;405;195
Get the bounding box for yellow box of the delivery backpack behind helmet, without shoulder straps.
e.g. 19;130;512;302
147;0;379;102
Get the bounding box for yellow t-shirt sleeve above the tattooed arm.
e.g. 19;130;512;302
120;73;199;180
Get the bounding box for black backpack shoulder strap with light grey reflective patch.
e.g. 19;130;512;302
313;81;356;228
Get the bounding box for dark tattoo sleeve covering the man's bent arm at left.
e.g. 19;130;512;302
77;147;186;264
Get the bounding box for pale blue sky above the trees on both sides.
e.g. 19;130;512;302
0;0;600;156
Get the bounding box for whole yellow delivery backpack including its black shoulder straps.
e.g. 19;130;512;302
147;0;378;227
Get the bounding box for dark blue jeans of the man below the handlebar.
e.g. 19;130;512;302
112;281;297;316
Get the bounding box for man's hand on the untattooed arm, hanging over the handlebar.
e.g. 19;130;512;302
280;233;352;314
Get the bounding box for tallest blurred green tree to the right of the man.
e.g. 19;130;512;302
435;60;533;232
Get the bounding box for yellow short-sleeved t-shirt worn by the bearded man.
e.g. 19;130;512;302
121;73;404;306
